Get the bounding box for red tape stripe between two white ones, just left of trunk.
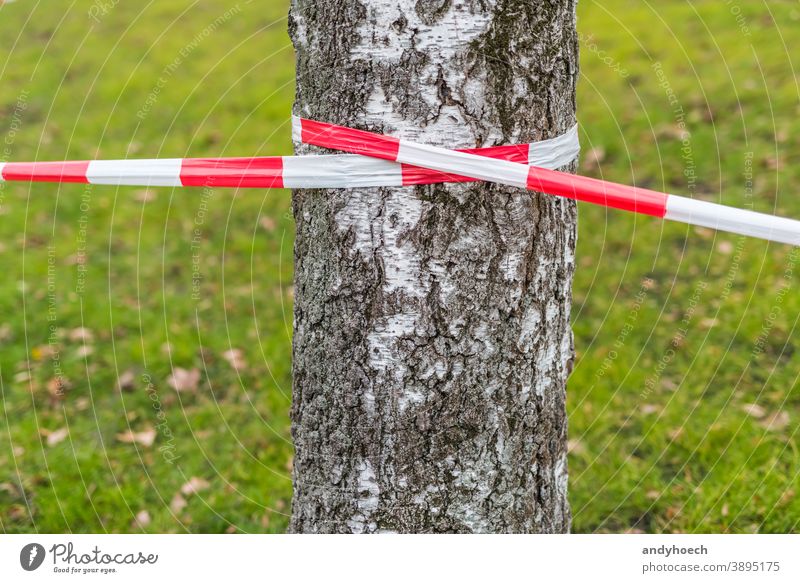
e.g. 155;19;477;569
181;156;283;188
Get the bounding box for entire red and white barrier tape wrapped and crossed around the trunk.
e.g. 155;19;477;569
0;117;800;245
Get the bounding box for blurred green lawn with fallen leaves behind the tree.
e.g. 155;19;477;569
0;0;800;533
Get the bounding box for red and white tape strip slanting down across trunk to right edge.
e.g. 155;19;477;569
294;119;800;245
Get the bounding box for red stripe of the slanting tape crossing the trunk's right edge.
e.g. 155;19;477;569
528;167;669;218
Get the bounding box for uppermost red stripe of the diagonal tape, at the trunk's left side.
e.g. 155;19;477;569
300;119;400;162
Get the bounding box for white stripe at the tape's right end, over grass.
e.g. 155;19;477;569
664;194;800;245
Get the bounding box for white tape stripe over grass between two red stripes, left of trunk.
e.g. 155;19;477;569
86;158;182;186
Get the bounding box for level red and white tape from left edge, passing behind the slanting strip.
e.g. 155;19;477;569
0;126;580;188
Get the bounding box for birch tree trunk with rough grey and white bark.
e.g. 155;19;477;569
289;0;578;532
